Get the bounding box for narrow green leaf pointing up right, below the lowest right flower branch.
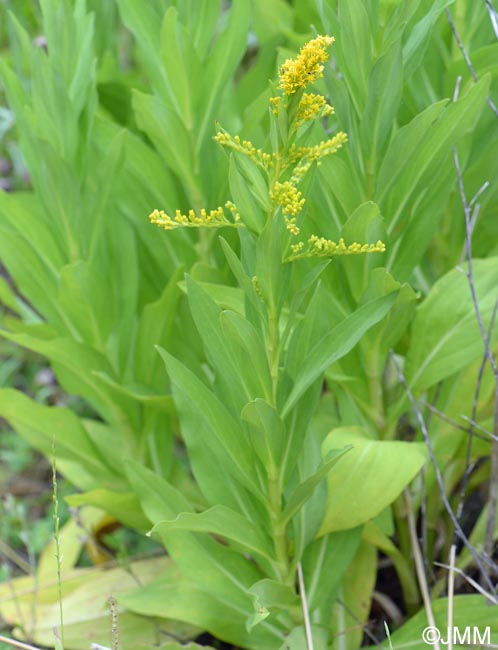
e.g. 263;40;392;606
283;291;397;416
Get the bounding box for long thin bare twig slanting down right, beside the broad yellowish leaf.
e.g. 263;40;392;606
391;350;496;592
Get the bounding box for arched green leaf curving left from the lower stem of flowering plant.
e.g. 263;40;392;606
151;505;273;560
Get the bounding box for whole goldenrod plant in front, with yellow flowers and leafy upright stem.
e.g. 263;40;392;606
117;36;425;648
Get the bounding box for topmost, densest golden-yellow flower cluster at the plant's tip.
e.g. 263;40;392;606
278;36;335;95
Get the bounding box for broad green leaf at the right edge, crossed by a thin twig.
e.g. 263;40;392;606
405;257;498;393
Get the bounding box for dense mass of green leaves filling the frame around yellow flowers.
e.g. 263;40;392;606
0;0;498;650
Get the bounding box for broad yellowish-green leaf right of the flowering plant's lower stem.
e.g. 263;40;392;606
319;427;426;535
